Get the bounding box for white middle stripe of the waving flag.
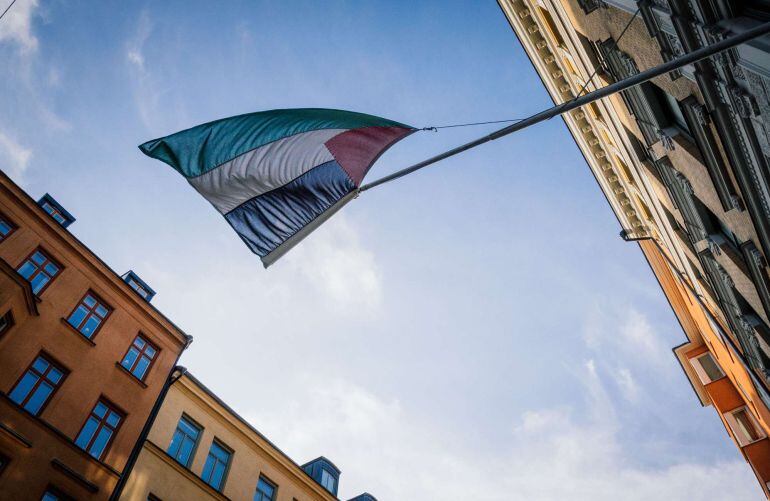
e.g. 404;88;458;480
188;129;348;214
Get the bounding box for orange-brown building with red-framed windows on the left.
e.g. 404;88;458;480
0;171;192;501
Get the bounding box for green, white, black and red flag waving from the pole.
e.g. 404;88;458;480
139;108;415;267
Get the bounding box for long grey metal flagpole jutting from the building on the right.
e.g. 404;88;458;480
358;22;770;193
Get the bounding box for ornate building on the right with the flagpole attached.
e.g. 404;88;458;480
498;0;770;495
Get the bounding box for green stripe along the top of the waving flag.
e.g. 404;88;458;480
139;108;413;178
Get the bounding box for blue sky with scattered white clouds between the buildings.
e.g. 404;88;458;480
0;0;761;501
